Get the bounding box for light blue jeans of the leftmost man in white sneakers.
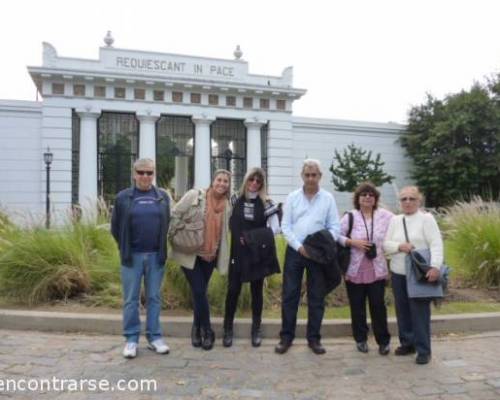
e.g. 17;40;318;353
121;253;165;343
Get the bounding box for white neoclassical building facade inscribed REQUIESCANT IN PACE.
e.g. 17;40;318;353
0;34;408;220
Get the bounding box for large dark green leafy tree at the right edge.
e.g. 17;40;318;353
400;77;500;207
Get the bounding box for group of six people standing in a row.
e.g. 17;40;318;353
111;159;443;364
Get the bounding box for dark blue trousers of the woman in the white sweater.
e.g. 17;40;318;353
392;273;431;355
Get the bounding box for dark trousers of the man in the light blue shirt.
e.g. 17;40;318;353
280;246;325;343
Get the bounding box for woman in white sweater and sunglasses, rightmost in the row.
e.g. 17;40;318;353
384;186;443;364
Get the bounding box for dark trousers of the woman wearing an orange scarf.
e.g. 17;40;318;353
182;257;215;330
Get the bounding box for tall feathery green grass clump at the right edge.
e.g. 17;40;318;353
442;197;500;287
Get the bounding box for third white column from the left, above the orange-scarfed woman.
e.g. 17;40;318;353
192;115;215;188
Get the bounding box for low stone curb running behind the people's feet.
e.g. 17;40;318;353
0;309;500;338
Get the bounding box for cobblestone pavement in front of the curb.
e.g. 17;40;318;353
0;330;500;400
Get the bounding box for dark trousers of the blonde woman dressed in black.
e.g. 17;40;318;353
224;264;264;330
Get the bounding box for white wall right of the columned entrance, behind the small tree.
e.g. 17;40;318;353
292;117;411;213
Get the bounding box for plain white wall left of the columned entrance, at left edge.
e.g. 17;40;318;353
0;100;44;217
